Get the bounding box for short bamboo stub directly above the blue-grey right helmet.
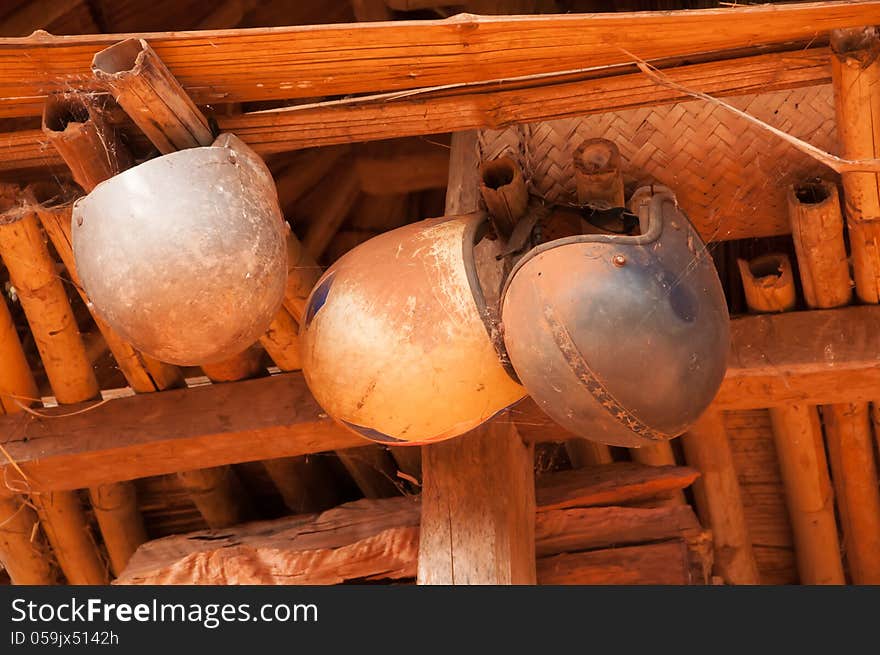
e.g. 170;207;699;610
574;139;625;208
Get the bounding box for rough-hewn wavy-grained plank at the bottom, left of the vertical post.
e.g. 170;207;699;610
115;497;419;584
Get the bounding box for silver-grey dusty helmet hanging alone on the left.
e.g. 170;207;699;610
72;135;287;365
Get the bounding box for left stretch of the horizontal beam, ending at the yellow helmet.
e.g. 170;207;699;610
0;373;360;489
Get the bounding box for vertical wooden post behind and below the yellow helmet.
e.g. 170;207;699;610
418;132;535;584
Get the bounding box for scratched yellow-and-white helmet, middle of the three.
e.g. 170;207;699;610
301;215;525;443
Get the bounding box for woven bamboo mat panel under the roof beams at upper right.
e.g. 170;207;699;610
478;85;838;241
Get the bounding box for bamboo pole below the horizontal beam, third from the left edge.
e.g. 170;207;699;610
89;482;147;576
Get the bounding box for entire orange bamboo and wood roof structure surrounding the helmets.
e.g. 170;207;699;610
0;0;880;585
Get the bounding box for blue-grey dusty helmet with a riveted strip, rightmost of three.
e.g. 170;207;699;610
502;192;729;447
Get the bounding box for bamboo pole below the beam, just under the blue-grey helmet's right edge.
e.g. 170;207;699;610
682;407;760;584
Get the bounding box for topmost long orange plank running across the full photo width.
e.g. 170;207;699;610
0;0;880;116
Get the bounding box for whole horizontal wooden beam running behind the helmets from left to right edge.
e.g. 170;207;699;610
0;306;880;489
